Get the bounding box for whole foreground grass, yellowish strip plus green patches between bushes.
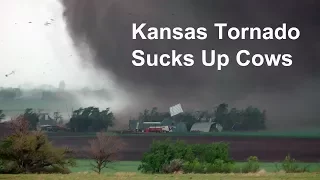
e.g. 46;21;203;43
0;160;320;180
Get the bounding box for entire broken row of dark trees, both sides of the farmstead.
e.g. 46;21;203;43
0;103;266;132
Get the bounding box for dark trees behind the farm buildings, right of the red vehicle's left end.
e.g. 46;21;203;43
132;103;266;131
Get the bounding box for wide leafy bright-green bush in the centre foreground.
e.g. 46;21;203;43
138;139;232;173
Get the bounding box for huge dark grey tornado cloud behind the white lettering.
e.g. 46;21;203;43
62;0;320;129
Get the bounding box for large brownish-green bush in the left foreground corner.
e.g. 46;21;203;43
0;116;75;173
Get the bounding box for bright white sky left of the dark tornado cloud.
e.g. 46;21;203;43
0;0;112;88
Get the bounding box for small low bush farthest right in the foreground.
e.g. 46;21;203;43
281;155;309;173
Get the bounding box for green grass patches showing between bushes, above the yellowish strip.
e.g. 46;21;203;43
71;160;320;173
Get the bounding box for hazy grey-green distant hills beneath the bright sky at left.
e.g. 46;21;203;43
0;87;110;117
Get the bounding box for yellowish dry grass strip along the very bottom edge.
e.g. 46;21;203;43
0;172;320;180
